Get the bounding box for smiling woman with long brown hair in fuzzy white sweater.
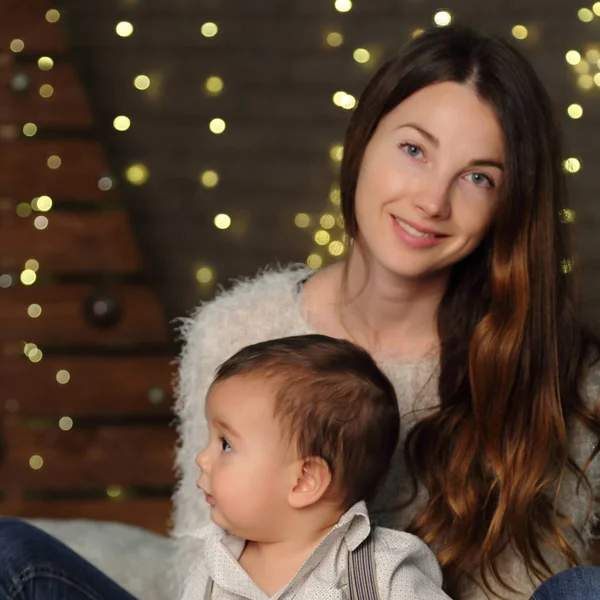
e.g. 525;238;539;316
0;27;600;600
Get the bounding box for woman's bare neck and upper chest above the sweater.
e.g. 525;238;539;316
307;247;447;359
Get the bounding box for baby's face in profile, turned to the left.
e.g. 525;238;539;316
196;376;297;541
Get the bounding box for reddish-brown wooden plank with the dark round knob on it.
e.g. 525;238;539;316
0;284;168;348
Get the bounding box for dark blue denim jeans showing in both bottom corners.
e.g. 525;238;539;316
0;518;600;600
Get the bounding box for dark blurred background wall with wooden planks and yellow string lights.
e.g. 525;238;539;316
0;0;600;532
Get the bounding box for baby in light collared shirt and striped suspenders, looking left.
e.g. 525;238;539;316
183;335;449;600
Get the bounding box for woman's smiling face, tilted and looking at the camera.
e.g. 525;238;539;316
355;82;505;279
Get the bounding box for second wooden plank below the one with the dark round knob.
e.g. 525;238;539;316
0;415;176;488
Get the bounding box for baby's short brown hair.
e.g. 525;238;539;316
213;335;400;509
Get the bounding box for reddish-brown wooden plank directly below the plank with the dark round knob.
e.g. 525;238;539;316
0;356;174;417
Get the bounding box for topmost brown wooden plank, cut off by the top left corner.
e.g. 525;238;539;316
0;0;67;53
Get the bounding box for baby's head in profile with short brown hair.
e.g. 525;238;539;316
196;335;400;541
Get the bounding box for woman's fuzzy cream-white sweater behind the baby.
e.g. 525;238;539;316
173;268;600;600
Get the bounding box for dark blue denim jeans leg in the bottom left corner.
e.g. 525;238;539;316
0;517;135;600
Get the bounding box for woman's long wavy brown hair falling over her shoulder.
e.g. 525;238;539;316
341;27;600;594
